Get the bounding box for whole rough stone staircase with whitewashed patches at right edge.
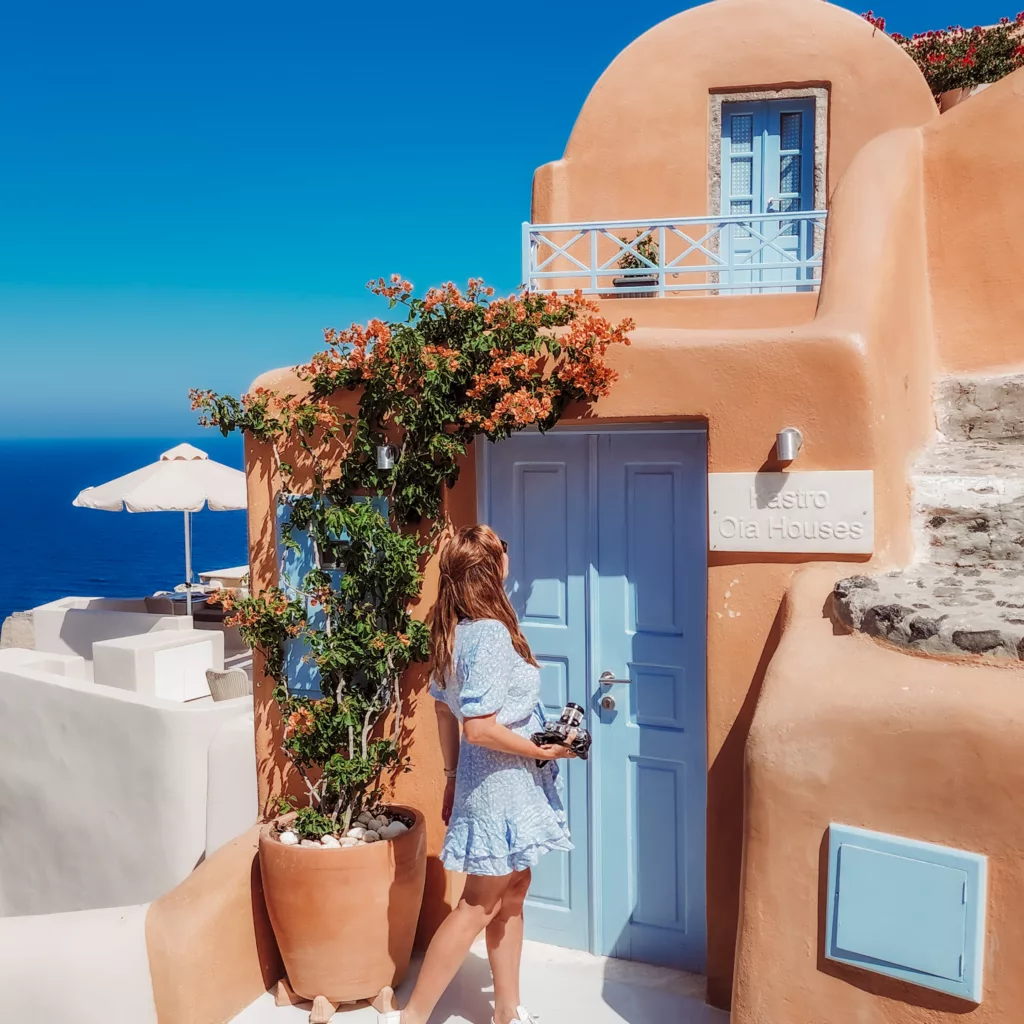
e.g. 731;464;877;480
834;374;1024;660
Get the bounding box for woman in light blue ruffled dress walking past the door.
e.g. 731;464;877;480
382;526;572;1024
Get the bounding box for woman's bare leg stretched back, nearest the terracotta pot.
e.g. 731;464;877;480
401;874;515;1024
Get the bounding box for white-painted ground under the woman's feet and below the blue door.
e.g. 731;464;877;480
233;942;729;1024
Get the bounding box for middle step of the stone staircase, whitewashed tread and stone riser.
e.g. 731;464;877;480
911;439;1024;565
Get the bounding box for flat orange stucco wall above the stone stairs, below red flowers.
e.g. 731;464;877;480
924;71;1024;373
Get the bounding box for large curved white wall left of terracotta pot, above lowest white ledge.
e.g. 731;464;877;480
0;650;256;916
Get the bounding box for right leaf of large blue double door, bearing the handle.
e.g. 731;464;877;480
594;432;707;971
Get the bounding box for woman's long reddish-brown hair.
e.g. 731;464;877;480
430;525;537;687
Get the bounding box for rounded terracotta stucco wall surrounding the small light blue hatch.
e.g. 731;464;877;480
732;566;1024;1024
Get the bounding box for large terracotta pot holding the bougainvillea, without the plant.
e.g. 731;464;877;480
259;807;427;1002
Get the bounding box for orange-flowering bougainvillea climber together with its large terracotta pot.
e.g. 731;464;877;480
193;276;633;1020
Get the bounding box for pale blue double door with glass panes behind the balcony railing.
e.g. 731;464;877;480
721;97;815;293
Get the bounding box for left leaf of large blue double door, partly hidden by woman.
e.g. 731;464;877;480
484;434;590;949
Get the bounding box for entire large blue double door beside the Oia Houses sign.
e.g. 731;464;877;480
481;430;707;971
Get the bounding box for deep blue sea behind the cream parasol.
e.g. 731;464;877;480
0;431;249;621
